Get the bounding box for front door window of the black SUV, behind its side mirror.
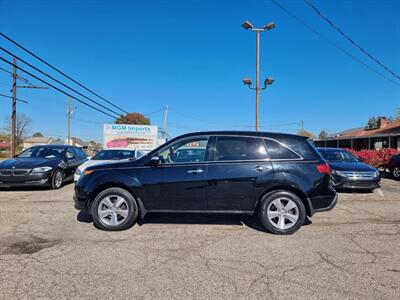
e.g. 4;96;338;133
159;138;208;164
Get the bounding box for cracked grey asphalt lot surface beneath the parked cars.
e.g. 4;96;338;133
0;179;400;299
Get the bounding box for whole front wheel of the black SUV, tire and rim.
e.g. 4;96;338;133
91;188;139;231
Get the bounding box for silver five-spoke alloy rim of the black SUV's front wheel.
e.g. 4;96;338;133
97;195;129;226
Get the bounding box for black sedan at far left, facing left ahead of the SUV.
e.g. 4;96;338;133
0;145;86;189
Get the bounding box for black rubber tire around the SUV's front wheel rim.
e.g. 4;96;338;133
90;188;139;231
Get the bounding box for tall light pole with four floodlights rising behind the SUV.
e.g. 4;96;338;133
242;21;275;131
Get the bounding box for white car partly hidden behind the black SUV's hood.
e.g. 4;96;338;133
74;148;144;183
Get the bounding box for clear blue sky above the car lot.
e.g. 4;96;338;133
0;0;400;141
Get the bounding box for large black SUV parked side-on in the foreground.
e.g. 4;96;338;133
74;131;337;234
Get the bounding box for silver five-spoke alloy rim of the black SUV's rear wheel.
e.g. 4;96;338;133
267;198;299;230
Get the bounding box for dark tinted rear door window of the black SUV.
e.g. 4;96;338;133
215;137;267;161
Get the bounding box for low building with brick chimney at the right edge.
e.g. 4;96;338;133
314;117;400;150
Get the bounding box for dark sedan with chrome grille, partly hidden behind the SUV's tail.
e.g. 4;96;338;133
318;148;380;190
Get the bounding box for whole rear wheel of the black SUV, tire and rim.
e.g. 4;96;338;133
258;190;306;234
